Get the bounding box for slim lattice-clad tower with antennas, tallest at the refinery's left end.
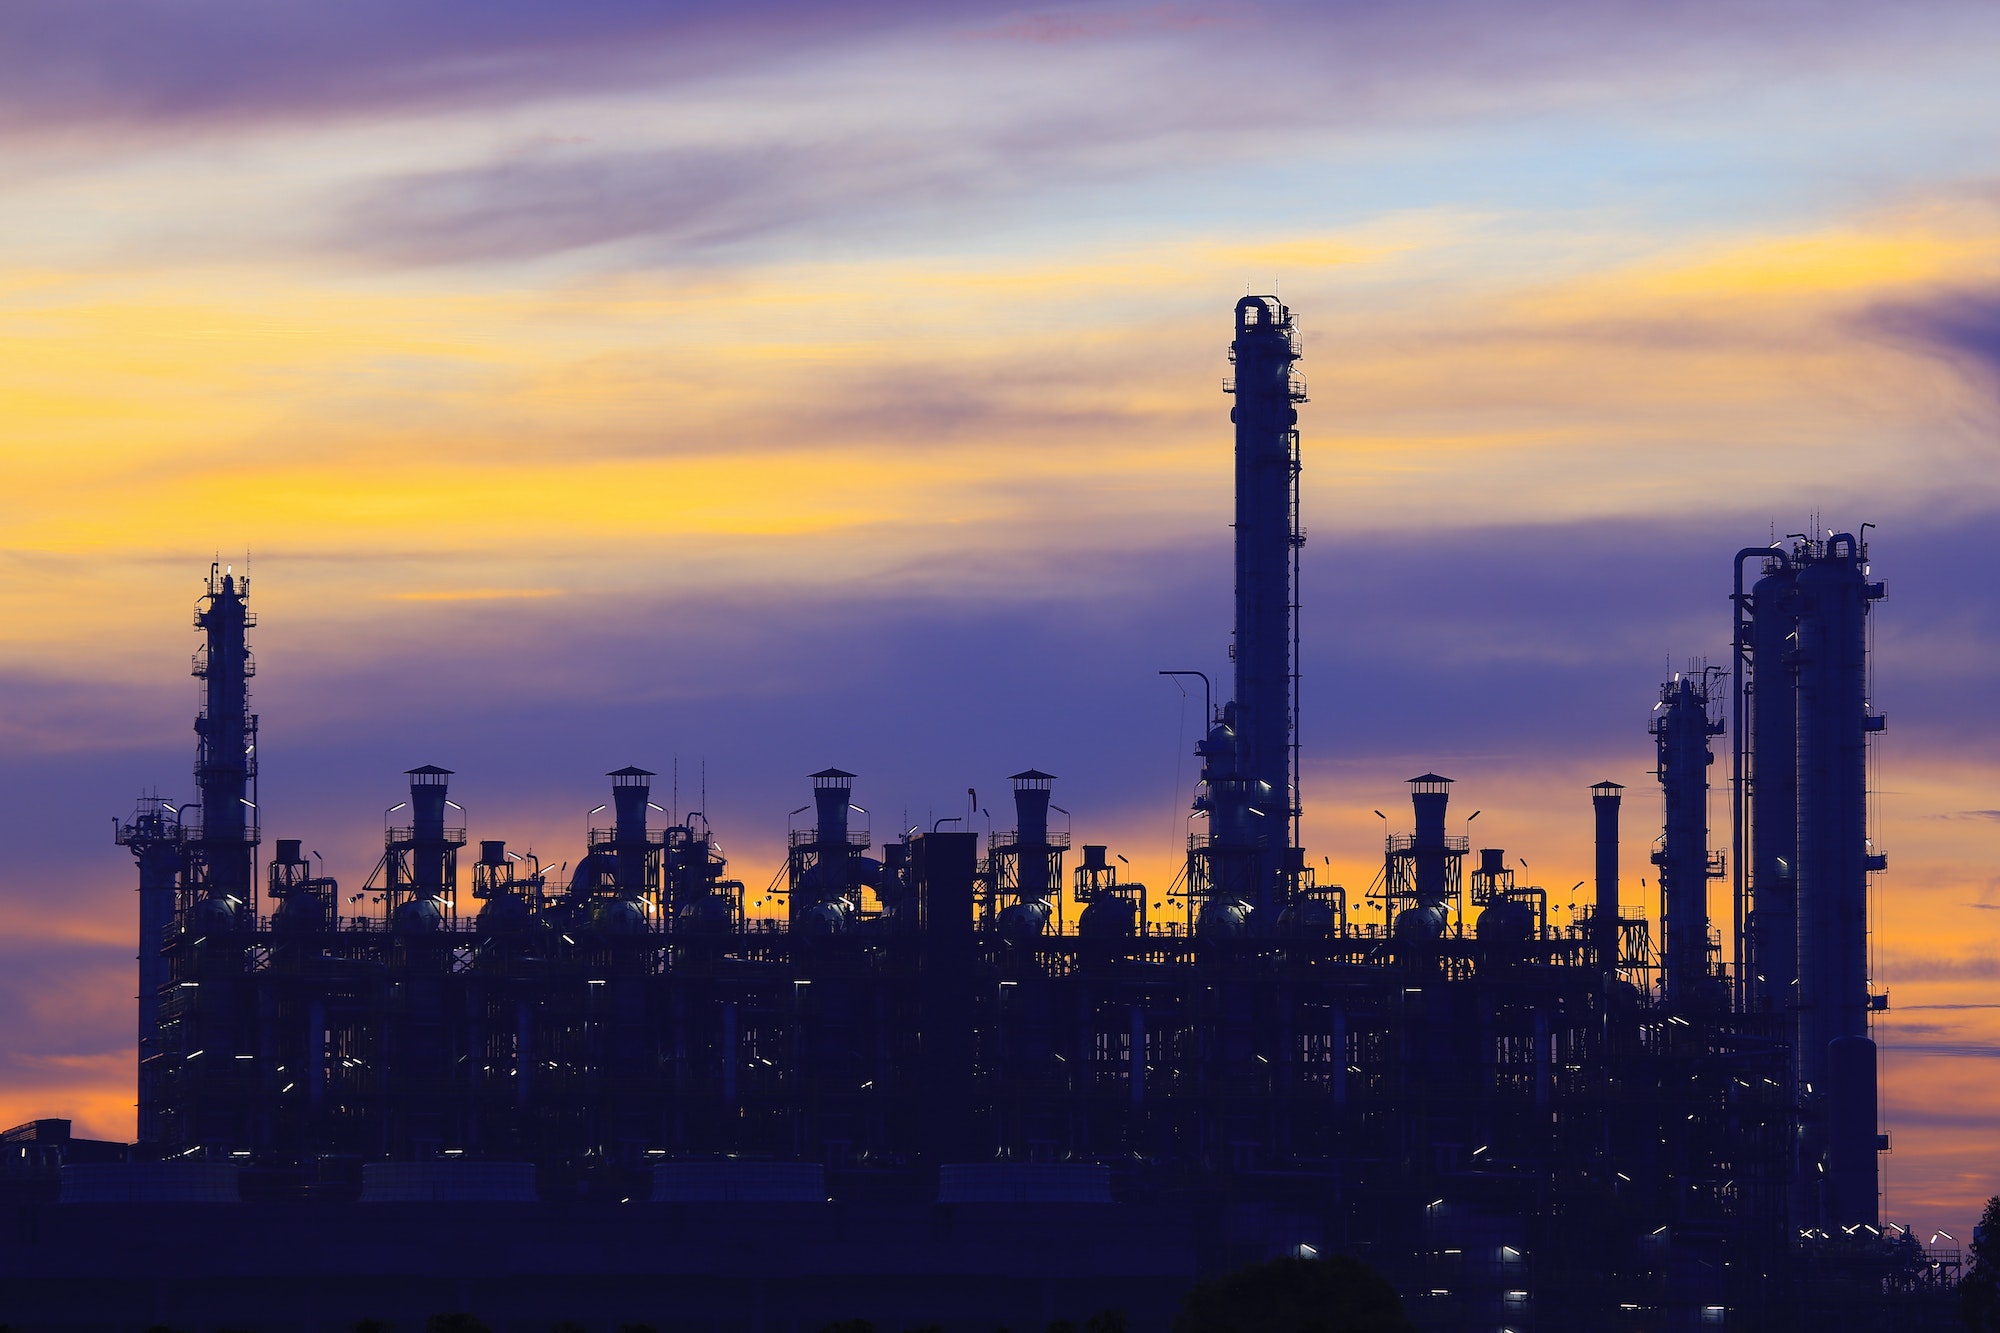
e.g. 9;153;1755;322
188;564;258;912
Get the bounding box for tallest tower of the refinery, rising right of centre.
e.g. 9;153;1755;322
1210;296;1306;933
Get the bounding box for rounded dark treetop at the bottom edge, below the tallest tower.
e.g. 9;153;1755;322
1174;1255;1416;1333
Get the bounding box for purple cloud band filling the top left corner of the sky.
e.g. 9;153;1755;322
0;0;928;126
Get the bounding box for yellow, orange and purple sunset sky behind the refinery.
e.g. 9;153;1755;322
0;0;2000;1239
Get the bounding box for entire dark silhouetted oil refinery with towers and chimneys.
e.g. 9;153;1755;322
0;296;1956;1333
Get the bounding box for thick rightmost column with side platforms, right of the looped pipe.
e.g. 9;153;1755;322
1794;532;1886;1225
